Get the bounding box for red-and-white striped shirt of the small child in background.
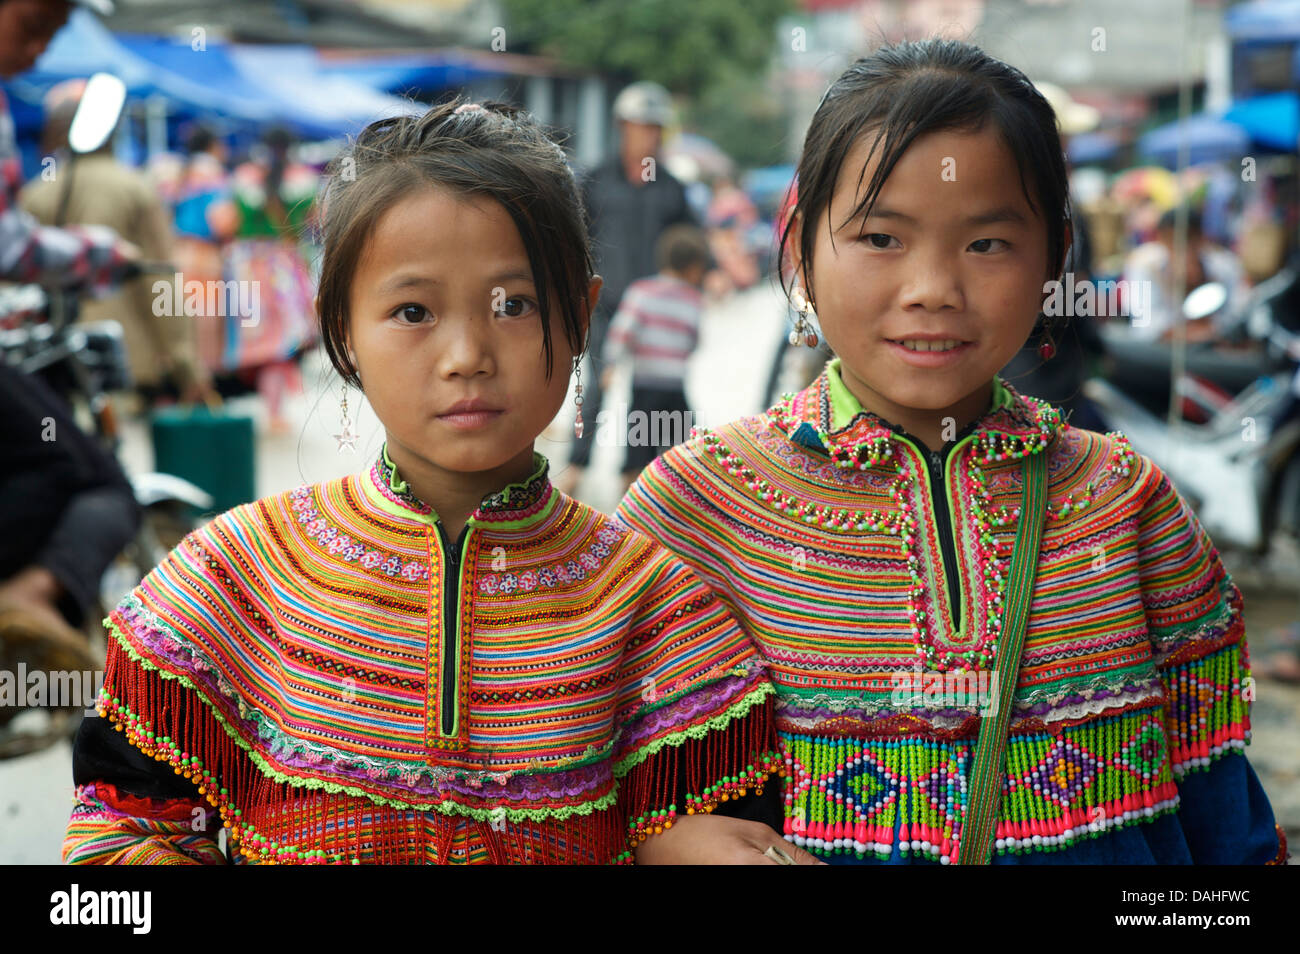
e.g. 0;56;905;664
603;274;705;387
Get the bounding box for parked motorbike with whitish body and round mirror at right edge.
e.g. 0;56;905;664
1084;280;1300;555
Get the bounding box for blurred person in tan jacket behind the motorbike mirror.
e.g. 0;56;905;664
21;79;212;407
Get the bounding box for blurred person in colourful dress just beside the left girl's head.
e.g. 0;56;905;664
226;129;317;434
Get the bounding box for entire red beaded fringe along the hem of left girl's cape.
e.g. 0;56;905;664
100;641;779;864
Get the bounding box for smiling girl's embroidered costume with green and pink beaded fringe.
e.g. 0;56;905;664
618;360;1286;864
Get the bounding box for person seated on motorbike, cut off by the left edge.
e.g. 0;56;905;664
0;0;139;717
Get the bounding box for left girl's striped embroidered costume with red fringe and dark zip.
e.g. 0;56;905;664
64;451;780;863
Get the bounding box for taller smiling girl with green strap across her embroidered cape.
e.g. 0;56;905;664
619;40;1287;864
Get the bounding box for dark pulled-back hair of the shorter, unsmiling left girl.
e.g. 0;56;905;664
319;96;594;389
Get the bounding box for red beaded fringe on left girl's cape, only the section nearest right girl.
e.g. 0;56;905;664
615;697;785;864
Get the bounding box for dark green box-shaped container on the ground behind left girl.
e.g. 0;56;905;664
151;404;257;513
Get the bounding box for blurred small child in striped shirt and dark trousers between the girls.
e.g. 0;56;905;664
605;225;712;494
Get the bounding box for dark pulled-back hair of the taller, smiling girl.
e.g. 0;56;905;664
779;39;1071;308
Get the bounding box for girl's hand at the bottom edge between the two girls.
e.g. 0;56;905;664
636;815;826;864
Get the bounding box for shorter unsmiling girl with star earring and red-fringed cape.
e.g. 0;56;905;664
64;103;815;864
